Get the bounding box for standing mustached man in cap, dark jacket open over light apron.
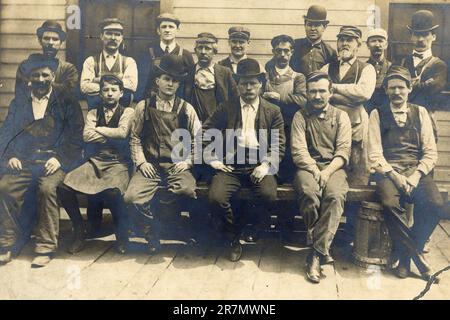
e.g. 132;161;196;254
184;32;238;122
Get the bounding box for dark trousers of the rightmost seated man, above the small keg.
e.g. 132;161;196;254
377;174;444;270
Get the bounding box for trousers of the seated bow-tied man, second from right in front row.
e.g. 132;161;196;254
294;169;348;256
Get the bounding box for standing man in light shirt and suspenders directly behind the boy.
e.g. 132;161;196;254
80;18;138;109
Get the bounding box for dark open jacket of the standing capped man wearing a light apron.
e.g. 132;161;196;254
183;63;238;109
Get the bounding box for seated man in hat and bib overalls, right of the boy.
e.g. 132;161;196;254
125;55;201;253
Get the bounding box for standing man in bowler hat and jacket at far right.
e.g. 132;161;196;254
400;10;447;138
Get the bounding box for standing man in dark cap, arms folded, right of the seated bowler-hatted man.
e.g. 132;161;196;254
263;35;306;181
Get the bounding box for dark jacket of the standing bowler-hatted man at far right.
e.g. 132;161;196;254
400;54;447;110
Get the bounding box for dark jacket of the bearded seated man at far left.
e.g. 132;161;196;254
0;87;84;172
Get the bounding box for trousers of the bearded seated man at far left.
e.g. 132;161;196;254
0;165;65;254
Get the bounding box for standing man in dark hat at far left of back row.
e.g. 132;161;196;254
15;20;78;97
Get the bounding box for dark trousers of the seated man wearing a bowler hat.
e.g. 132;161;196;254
208;168;277;241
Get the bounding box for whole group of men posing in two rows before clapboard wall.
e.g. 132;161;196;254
0;5;447;283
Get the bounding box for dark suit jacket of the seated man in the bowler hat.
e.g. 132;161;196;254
203;97;286;165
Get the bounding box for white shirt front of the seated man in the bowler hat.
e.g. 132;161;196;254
238;98;259;149
